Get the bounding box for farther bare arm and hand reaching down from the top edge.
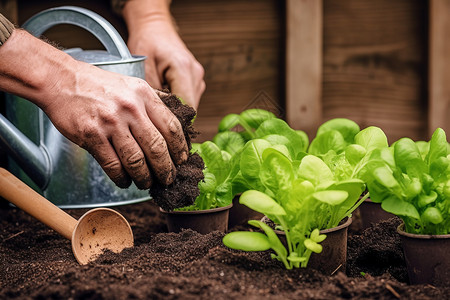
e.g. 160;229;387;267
122;0;205;110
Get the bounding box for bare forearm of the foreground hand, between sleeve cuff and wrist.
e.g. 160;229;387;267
0;29;77;108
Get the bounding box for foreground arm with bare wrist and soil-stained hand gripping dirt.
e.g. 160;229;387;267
0;15;188;189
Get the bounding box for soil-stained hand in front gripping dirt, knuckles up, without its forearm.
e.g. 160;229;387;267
41;62;188;189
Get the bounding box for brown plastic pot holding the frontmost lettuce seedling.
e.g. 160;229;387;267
275;218;352;275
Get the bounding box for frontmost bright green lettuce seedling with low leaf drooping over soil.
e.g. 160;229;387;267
223;148;365;269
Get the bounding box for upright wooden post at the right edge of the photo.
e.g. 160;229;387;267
428;0;450;136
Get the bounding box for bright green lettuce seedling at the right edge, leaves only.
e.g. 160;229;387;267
363;128;450;235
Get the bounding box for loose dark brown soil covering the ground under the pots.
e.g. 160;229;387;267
0;201;450;300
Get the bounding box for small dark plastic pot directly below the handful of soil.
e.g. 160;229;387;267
160;204;233;234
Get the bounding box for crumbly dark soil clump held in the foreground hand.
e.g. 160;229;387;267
150;93;205;211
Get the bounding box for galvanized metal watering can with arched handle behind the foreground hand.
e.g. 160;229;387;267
0;6;150;208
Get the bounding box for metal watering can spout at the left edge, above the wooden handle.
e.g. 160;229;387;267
0;114;51;189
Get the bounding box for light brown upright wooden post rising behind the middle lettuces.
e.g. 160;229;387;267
286;0;323;138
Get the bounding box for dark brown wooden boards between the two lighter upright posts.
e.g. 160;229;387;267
322;0;428;142
